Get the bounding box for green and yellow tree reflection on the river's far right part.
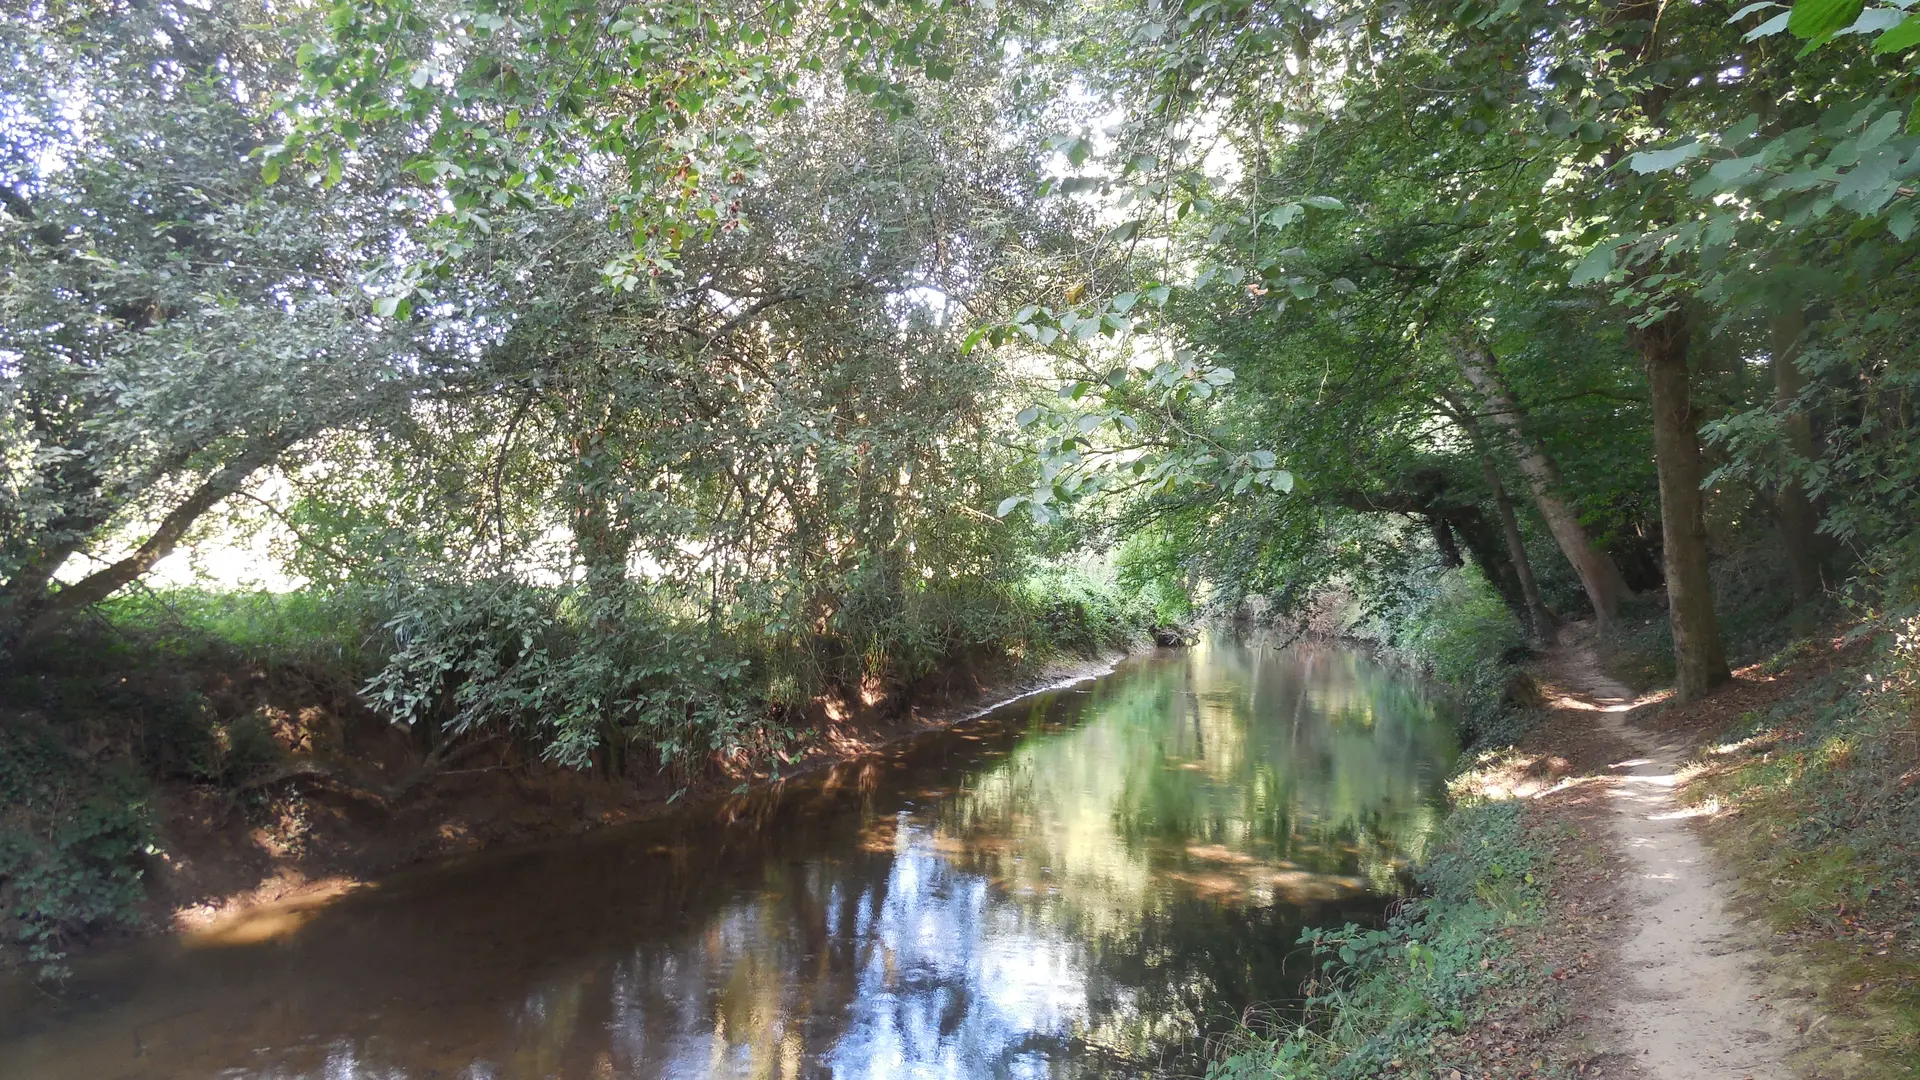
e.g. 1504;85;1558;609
906;638;1450;1057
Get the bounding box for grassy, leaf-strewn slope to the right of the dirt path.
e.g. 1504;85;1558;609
1682;626;1920;1078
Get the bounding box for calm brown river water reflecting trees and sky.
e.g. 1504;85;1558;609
0;642;1452;1080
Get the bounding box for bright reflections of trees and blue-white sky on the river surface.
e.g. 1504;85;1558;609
439;634;1448;1076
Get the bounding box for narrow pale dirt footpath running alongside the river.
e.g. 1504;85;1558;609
1548;626;1795;1080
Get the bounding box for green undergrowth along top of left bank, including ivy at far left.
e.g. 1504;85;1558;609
0;565;1156;976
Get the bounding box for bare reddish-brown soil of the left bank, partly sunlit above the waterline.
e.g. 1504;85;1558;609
142;641;1123;944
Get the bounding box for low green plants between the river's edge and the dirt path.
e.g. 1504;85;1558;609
1208;801;1549;1080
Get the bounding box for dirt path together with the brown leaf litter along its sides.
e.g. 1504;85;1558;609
1448;625;1884;1080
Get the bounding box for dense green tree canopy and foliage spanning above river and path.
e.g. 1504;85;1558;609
11;0;1920;983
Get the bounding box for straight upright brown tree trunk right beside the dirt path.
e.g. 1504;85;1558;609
1634;311;1732;701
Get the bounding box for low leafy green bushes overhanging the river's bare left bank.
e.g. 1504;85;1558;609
363;567;1146;769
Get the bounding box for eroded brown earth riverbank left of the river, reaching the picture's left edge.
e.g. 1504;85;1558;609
0;634;1127;976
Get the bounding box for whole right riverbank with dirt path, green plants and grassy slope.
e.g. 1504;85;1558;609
1223;614;1920;1080
